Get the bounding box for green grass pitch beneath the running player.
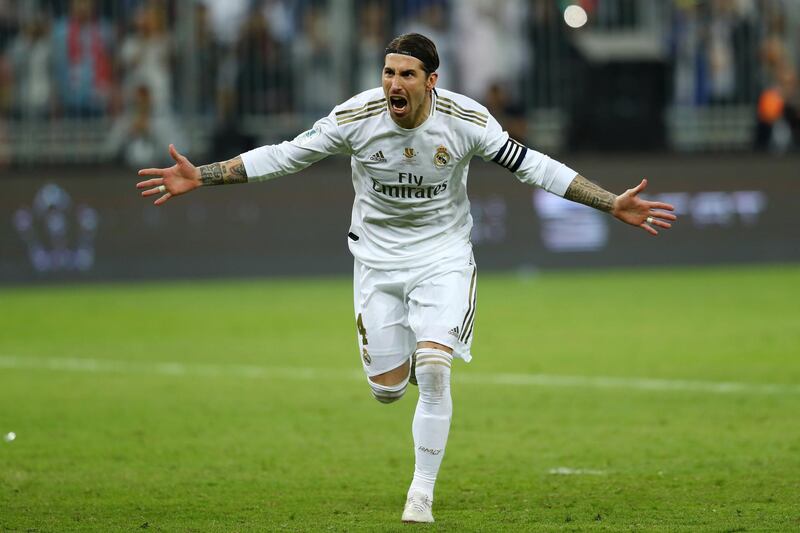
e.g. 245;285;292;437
0;266;800;532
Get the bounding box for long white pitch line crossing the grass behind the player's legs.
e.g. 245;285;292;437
0;355;800;394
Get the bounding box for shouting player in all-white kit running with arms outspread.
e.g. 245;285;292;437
137;34;676;522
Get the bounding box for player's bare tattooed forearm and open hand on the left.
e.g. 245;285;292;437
136;144;247;205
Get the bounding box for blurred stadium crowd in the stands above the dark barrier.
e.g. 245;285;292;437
0;0;800;166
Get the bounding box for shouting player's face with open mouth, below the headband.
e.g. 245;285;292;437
383;54;438;128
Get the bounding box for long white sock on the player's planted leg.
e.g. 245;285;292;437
408;348;453;500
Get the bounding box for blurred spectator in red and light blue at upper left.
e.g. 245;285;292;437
53;0;114;116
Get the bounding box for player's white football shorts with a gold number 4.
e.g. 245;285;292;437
353;252;477;377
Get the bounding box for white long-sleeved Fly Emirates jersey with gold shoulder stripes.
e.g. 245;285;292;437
242;88;576;270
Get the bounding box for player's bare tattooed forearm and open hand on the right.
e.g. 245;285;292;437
564;174;678;235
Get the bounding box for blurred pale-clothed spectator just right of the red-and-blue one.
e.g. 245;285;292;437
119;3;172;113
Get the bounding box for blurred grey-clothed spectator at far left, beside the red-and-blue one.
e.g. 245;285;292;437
7;14;53;118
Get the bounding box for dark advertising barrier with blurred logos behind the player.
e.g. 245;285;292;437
0;154;800;283
